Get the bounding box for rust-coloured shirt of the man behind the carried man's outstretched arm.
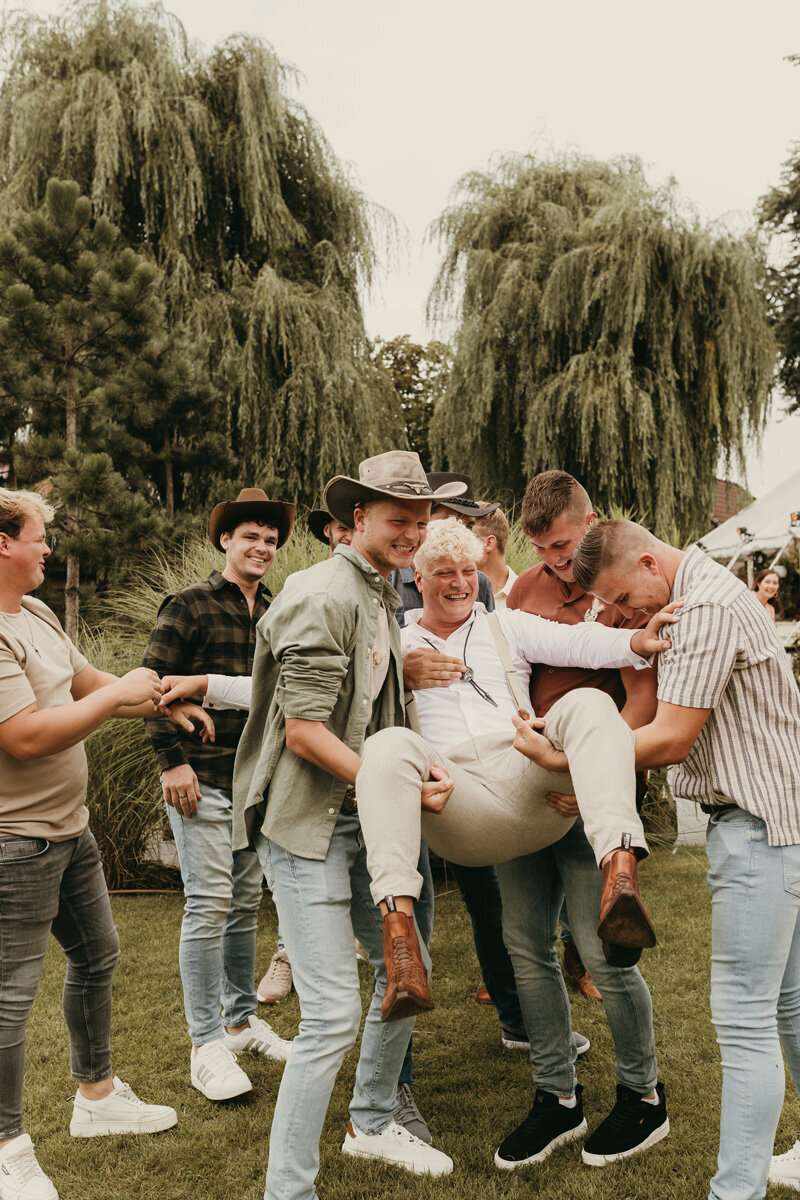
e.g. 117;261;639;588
507;563;643;716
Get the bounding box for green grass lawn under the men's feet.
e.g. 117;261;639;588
18;847;800;1200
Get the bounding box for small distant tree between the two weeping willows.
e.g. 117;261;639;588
372;334;452;470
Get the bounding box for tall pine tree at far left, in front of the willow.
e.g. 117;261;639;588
0;180;163;637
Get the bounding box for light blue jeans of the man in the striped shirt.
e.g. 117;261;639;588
706;811;800;1200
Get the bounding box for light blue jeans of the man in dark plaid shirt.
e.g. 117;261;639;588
167;782;261;1046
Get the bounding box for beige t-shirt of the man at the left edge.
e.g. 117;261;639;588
0;596;89;841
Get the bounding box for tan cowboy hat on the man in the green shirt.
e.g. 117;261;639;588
323;450;465;527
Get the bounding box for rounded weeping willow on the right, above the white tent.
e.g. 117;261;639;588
428;156;775;538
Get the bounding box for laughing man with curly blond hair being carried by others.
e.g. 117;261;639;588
356;521;675;1020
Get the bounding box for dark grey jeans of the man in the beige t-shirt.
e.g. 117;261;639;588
0;829;120;1140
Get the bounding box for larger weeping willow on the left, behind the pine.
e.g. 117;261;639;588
0;0;403;498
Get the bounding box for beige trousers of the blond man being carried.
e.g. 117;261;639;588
356;688;646;904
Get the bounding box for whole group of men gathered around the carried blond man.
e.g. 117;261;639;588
0;451;800;1200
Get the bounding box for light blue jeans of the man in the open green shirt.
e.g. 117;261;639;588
255;816;429;1200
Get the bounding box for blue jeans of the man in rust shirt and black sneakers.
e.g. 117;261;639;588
498;818;658;1096
